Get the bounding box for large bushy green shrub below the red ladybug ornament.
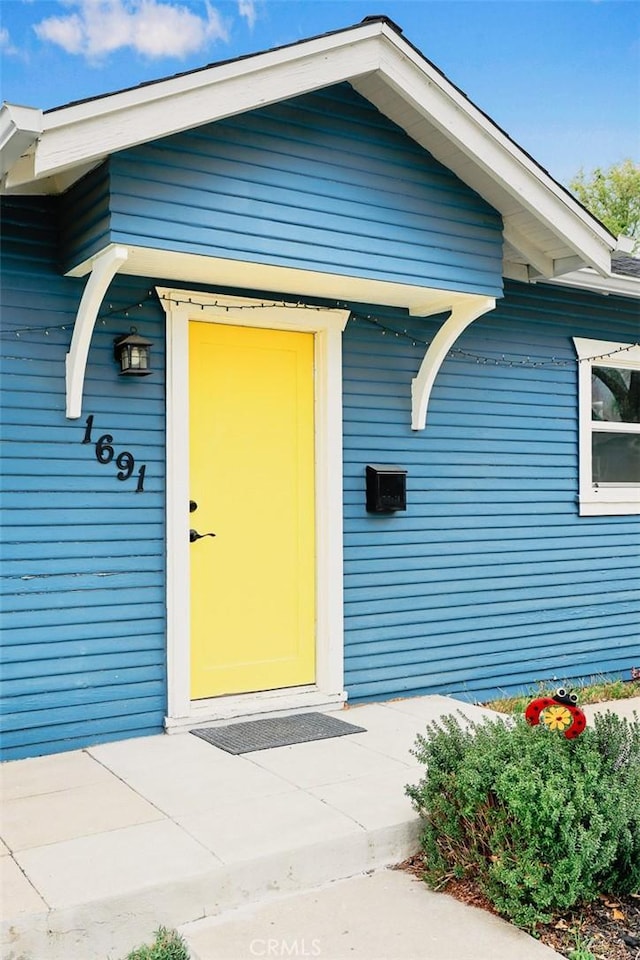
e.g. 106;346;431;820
407;713;640;928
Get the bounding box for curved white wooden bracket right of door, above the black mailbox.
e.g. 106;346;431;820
411;296;496;430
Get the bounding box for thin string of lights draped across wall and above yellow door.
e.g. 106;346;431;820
0;290;640;368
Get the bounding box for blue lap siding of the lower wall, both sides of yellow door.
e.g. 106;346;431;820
0;210;640;758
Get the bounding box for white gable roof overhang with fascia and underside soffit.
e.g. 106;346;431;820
0;17;616;279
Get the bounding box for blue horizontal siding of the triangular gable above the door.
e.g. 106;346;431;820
105;84;502;296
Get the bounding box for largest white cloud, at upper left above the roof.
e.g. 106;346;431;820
34;0;227;61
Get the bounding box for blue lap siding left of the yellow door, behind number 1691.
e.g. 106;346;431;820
0;198;166;759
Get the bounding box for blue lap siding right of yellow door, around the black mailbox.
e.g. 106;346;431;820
344;283;640;701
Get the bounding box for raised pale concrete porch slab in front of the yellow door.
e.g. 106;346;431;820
0;697;640;960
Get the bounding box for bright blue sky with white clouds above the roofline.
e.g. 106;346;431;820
0;0;640;183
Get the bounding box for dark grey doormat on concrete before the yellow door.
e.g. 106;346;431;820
191;713;366;754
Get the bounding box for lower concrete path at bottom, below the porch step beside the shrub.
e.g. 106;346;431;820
180;869;560;960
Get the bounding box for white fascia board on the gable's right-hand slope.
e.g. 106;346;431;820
381;47;616;274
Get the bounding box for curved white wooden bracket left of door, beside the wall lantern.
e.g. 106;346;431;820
65;246;129;420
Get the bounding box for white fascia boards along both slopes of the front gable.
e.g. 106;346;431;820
15;21;615;275
